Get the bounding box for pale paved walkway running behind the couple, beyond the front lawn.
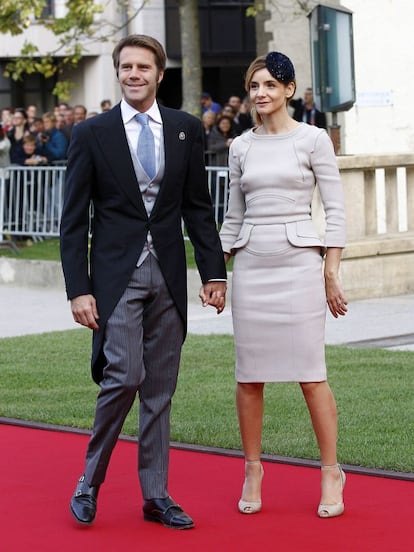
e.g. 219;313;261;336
0;285;414;351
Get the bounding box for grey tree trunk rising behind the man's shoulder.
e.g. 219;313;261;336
179;0;202;117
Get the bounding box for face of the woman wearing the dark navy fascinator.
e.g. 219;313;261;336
249;68;295;117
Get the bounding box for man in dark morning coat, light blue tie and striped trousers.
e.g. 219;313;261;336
61;35;226;529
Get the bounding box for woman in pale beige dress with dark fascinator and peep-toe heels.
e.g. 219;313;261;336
220;52;347;518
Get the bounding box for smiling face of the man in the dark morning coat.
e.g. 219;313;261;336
118;46;164;112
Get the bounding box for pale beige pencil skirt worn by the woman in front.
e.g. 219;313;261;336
232;224;326;382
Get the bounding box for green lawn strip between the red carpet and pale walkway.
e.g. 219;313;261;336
0;329;414;473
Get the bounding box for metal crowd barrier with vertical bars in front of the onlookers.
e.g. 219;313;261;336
0;166;229;241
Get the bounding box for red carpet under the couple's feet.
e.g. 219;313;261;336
0;424;414;552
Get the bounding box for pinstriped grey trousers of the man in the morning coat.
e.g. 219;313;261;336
85;254;184;499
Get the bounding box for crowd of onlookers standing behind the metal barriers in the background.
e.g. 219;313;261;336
0;89;326;175
